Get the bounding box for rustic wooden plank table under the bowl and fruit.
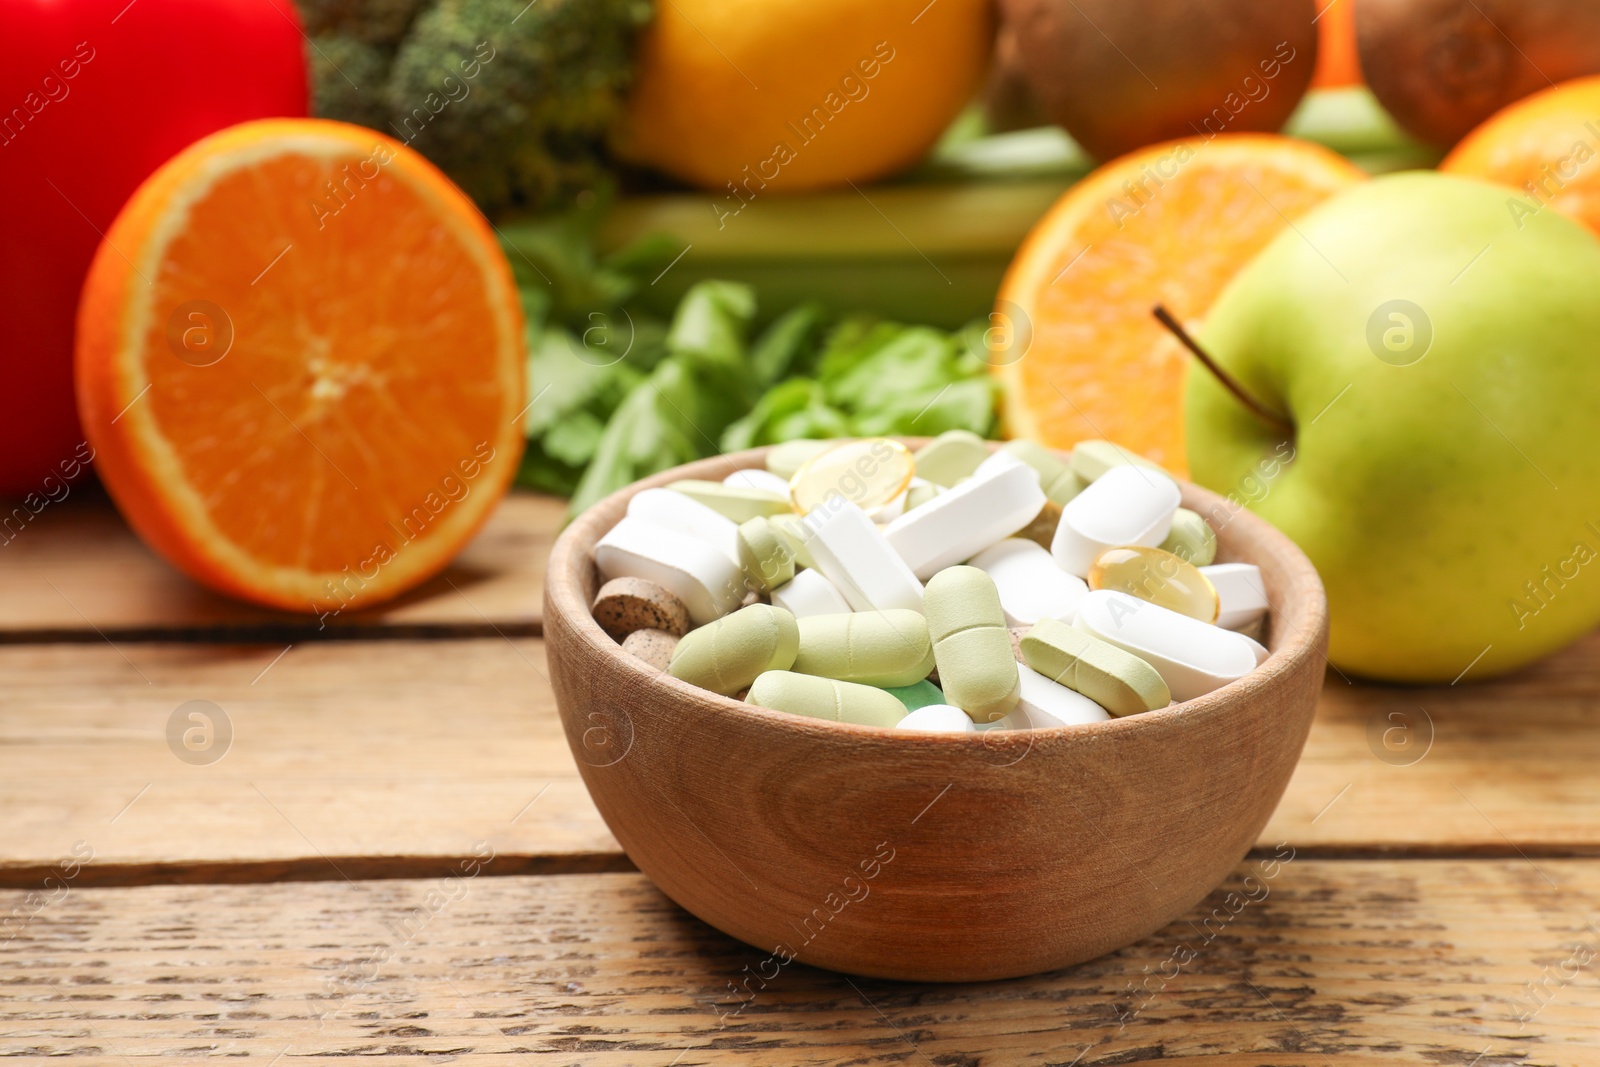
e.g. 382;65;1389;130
0;490;1600;1067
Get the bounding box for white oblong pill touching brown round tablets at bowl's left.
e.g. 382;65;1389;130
595;518;744;625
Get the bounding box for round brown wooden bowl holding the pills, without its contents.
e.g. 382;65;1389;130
544;450;1328;985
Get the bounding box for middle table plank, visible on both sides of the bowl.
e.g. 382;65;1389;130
9;638;1600;886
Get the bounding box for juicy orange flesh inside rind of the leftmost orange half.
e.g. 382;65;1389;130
144;155;502;571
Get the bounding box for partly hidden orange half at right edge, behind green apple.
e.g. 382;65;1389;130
1438;77;1600;234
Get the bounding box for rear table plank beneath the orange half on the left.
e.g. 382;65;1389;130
0;485;566;641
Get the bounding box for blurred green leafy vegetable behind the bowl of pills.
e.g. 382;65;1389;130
506;206;995;514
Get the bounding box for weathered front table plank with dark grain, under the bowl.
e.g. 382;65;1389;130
0;863;1600;1067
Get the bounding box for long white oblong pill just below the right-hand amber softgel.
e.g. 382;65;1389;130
1072;588;1256;701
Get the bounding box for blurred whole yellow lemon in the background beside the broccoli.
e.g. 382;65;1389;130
619;0;994;192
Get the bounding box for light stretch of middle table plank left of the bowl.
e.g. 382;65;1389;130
0;638;624;886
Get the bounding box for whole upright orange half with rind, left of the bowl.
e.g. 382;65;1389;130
77;120;525;613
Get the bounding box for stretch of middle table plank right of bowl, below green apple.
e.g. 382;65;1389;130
1262;620;1600;856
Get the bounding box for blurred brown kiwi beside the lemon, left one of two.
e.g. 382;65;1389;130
1000;0;1317;160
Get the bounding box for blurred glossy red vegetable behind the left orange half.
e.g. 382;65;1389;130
0;0;306;496
